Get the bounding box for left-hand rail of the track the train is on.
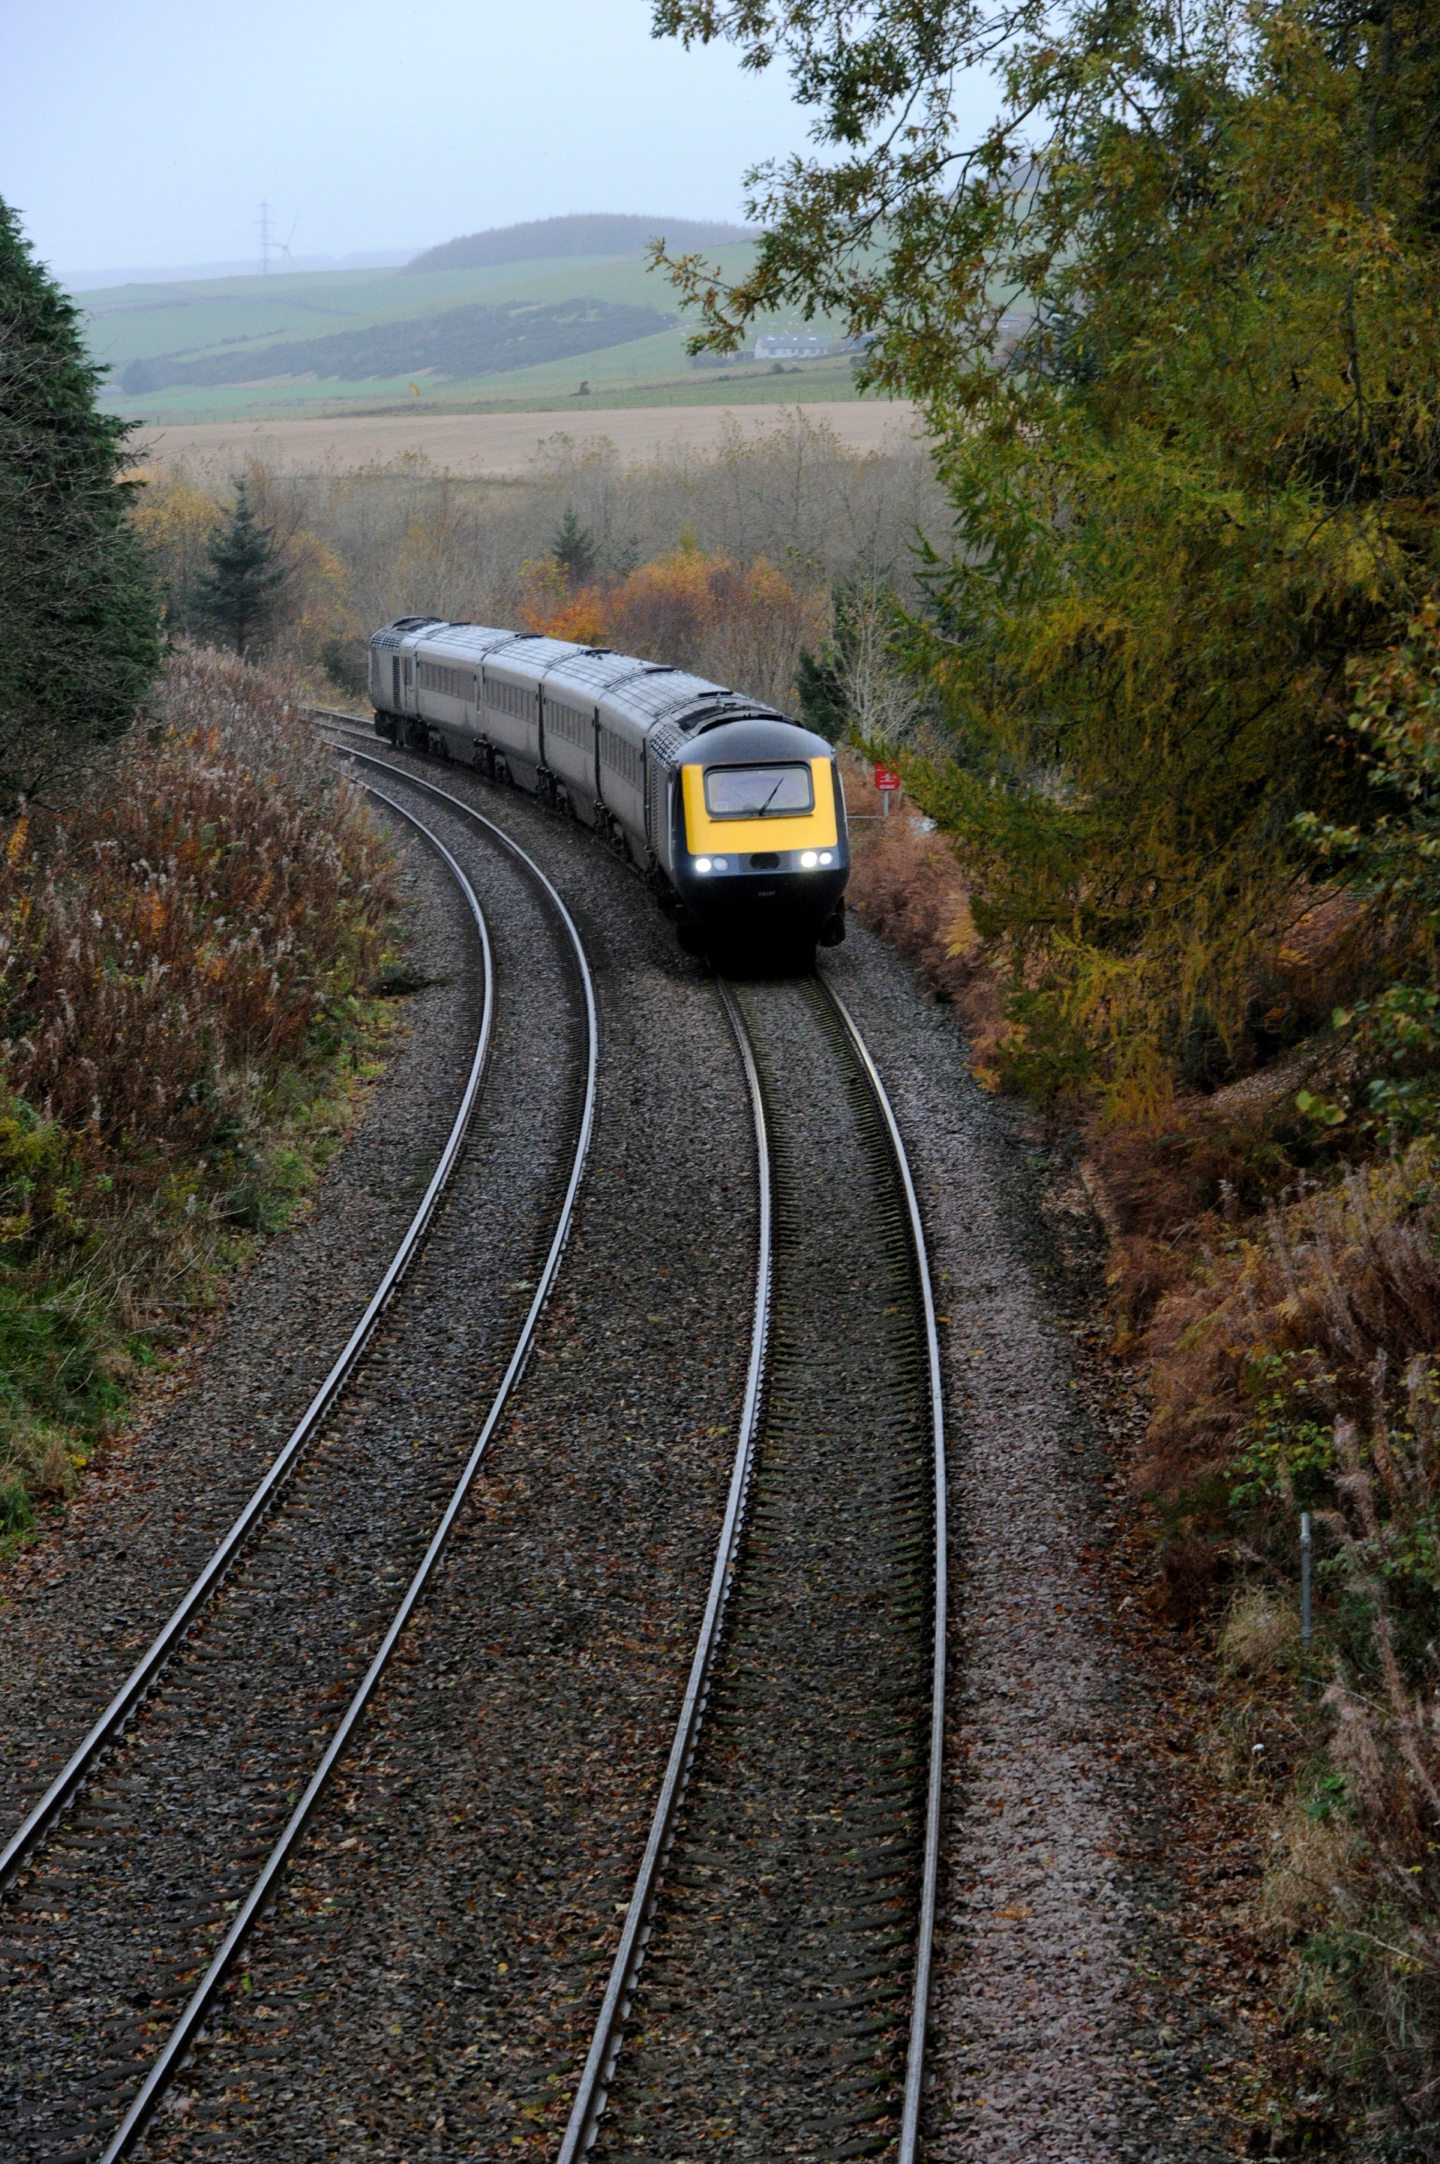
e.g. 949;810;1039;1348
557;978;775;2164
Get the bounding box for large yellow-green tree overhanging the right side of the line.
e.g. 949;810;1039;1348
656;0;1440;1119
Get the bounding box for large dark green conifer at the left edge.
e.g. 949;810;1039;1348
0;201;160;809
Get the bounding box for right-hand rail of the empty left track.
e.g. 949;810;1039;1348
100;753;600;2164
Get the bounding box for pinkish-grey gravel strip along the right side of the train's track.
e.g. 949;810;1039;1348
823;928;1249;2164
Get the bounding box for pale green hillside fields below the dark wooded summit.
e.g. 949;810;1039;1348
80;242;855;422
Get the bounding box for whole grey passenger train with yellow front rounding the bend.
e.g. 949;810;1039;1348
370;617;849;967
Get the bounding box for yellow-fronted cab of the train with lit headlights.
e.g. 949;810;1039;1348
673;716;849;959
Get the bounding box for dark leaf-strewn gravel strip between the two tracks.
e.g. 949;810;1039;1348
145;768;754;2164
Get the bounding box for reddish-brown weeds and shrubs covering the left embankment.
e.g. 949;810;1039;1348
0;649;390;1532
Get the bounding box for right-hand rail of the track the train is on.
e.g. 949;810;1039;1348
816;972;948;2164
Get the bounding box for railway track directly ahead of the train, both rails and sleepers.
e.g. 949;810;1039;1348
561;980;946;2164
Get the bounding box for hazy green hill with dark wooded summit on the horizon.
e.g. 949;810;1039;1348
80;216;853;420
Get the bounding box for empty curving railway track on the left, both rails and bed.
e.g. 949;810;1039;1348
0;777;598;2164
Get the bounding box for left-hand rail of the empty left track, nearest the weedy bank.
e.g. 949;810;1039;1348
0;790;496;1896
